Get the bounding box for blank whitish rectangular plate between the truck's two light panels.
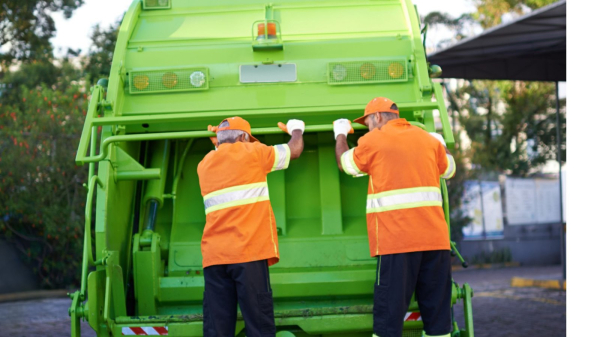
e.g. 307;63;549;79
240;63;297;83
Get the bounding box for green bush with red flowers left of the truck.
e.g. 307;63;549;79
0;62;88;288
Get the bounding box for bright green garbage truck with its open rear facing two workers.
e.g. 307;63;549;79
69;0;473;337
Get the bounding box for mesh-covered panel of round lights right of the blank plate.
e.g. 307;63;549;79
327;59;408;85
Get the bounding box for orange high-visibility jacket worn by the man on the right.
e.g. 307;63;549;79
341;118;456;256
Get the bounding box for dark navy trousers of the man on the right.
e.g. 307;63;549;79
373;250;452;337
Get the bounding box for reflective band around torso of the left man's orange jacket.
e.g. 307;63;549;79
204;182;269;214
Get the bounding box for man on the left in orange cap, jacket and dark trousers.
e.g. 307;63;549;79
198;117;304;337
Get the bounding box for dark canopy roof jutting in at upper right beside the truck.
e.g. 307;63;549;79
428;0;567;81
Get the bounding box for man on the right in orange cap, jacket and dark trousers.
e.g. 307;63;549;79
334;97;456;337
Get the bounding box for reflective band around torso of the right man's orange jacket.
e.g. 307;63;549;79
367;187;442;213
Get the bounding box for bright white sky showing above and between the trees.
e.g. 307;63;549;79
51;0;475;56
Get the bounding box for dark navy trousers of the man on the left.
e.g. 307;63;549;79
204;260;275;337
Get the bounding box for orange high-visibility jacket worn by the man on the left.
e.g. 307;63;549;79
198;142;290;268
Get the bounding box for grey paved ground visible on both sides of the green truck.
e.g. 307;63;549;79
0;267;566;337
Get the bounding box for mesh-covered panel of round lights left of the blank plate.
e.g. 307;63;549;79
129;67;209;94
